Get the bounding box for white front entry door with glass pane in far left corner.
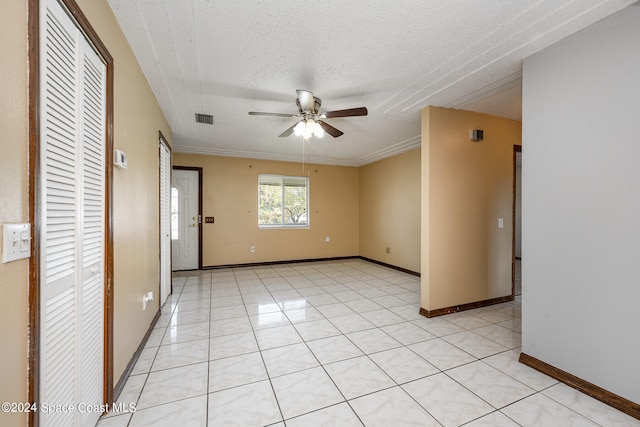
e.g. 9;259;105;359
171;169;201;270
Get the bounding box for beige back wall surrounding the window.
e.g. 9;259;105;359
173;153;359;267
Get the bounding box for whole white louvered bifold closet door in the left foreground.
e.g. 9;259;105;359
39;0;106;426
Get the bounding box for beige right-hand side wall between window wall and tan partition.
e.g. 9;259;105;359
360;149;420;272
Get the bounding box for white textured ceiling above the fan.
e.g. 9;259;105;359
108;0;635;166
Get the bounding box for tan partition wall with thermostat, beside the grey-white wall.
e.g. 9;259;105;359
421;107;521;310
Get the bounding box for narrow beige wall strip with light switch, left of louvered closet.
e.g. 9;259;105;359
0;1;29;426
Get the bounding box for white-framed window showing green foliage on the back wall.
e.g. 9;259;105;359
258;175;309;228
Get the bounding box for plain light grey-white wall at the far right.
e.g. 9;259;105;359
522;3;640;402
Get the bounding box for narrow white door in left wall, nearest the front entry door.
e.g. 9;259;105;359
160;139;171;307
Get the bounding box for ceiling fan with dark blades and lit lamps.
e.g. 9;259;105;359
249;89;368;139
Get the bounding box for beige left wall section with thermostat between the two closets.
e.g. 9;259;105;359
76;0;172;385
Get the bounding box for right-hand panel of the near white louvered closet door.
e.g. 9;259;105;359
77;25;106;426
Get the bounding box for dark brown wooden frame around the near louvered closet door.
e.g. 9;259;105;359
27;0;114;426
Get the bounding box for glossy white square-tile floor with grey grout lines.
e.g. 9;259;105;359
98;260;640;427
